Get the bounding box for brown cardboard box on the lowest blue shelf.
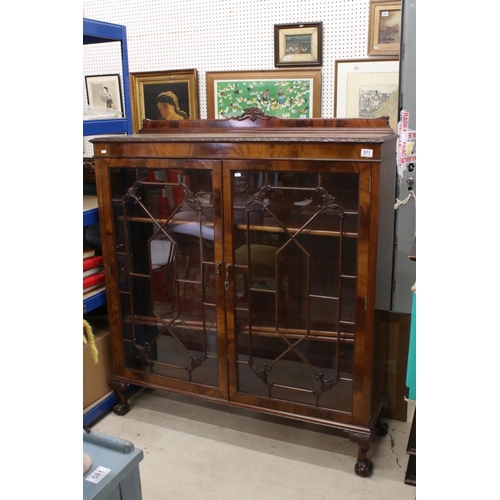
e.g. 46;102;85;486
83;328;111;409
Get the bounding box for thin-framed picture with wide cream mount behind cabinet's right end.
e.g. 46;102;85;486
334;59;399;131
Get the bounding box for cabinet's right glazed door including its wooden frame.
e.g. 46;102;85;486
223;160;370;423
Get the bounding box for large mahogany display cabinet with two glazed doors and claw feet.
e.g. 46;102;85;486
92;108;397;476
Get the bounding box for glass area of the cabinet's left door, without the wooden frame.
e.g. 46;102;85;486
113;165;218;386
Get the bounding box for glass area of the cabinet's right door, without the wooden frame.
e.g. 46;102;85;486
233;166;359;411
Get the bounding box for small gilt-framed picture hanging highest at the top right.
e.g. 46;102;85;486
368;0;401;56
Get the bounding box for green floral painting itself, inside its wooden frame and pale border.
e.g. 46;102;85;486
216;78;313;118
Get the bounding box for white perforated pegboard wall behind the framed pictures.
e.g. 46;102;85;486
83;0;369;156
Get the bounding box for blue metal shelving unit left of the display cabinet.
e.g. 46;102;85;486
83;18;132;426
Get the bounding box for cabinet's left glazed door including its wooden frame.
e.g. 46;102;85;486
102;159;227;398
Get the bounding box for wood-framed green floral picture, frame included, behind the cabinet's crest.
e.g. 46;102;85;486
206;69;321;119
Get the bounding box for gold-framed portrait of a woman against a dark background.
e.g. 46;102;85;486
130;69;200;133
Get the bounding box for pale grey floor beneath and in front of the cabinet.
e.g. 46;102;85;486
92;389;416;500
